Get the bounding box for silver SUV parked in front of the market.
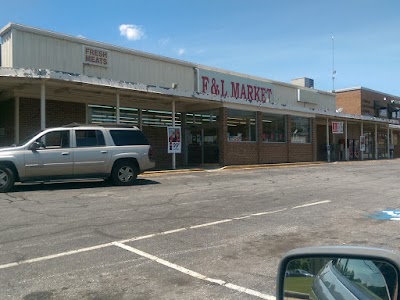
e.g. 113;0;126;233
0;124;155;193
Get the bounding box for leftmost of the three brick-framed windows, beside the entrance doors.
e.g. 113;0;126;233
227;109;257;142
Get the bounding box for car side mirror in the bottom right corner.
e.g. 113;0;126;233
276;246;400;300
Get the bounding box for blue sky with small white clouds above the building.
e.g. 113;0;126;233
0;0;400;96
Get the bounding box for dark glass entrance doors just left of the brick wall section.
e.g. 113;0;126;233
187;128;219;165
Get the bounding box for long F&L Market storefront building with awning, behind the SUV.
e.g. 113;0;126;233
0;24;399;169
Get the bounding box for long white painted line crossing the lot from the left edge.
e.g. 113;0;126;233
0;200;331;269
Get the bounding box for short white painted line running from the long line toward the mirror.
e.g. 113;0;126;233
113;242;275;300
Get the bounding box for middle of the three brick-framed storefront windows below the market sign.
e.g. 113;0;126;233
261;114;286;143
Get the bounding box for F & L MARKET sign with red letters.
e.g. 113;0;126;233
198;70;273;104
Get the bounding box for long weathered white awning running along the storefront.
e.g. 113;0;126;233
0;67;400;125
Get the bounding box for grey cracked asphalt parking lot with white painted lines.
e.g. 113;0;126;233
0;160;400;299
